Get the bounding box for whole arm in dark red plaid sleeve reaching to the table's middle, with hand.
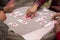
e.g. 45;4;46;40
26;0;48;18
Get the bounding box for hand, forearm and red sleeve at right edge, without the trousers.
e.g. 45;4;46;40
52;13;60;40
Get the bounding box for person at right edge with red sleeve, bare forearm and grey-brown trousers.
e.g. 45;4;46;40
41;13;60;40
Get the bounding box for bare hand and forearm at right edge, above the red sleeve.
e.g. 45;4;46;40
52;13;60;33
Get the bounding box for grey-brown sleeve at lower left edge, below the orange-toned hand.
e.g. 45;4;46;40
0;21;8;40
